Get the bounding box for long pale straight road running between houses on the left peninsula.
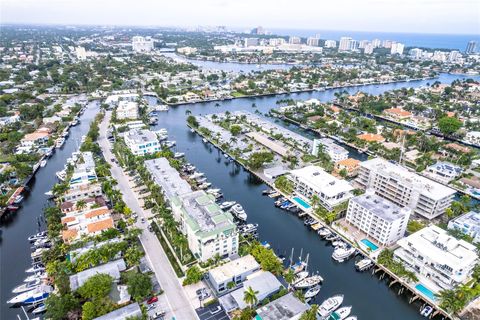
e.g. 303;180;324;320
98;111;198;320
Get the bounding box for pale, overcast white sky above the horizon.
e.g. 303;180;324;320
0;0;480;35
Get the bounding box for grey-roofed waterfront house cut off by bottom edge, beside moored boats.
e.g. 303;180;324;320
255;292;310;320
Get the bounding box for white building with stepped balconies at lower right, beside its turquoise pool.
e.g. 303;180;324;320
394;226;478;293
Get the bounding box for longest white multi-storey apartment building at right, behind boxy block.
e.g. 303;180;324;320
356;158;455;219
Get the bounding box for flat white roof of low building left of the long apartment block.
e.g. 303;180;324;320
290;166;353;197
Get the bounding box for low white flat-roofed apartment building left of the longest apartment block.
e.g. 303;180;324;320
289;166;353;210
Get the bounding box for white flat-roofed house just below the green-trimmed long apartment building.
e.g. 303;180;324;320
208;254;260;293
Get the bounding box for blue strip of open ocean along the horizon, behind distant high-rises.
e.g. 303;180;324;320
268;29;480;52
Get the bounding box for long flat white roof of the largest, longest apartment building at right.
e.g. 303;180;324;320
360;158;456;200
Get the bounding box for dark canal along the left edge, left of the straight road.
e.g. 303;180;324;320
0;102;99;320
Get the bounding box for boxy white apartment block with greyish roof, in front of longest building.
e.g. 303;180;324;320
346;190;411;246
